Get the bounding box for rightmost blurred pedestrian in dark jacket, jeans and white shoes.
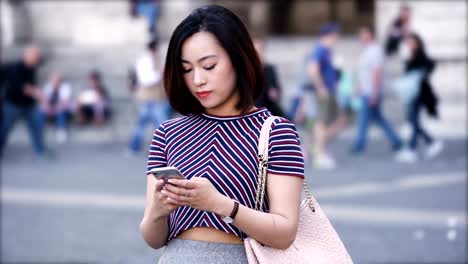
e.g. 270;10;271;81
397;33;443;163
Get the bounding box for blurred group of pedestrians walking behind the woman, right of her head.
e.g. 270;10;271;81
259;5;443;169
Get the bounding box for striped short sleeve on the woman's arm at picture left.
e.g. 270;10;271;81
146;124;167;174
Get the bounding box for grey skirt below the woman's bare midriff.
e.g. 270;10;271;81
158;239;247;264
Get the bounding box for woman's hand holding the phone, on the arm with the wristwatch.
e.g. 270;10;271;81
162;177;225;212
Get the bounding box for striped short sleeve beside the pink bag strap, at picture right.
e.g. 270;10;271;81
268;118;304;178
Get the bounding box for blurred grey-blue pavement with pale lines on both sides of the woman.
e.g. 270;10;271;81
0;134;467;263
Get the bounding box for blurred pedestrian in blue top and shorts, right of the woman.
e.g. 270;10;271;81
308;23;347;169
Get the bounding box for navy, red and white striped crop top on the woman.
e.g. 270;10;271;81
146;108;304;241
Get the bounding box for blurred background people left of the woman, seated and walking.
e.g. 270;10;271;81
0;0;164;159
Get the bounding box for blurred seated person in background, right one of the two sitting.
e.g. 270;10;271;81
75;70;111;125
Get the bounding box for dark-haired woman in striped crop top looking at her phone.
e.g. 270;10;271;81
140;5;304;263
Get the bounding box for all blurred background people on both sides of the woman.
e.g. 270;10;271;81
0;3;443;169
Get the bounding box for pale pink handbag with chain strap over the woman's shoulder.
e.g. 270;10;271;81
244;116;353;264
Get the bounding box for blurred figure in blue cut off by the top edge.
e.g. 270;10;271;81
130;0;161;38
